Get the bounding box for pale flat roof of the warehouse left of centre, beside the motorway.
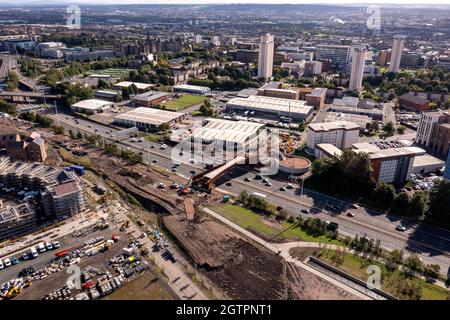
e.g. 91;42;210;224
114;107;184;126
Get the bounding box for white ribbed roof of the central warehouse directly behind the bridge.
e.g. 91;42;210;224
191;119;264;144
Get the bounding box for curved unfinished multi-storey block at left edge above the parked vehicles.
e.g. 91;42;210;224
0;157;86;234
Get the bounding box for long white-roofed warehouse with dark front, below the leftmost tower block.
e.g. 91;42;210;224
226;96;314;122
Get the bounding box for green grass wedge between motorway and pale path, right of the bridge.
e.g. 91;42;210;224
211;204;342;245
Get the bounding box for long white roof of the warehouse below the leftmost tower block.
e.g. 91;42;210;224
227;96;314;114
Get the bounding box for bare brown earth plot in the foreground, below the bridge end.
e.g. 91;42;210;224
163;212;355;300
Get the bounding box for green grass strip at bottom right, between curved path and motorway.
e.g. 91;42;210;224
319;249;449;300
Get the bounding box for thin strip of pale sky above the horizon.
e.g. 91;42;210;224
0;0;449;5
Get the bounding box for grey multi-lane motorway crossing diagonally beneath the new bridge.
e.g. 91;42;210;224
51;114;450;275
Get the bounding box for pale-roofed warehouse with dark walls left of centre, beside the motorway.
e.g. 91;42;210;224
114;107;185;130
